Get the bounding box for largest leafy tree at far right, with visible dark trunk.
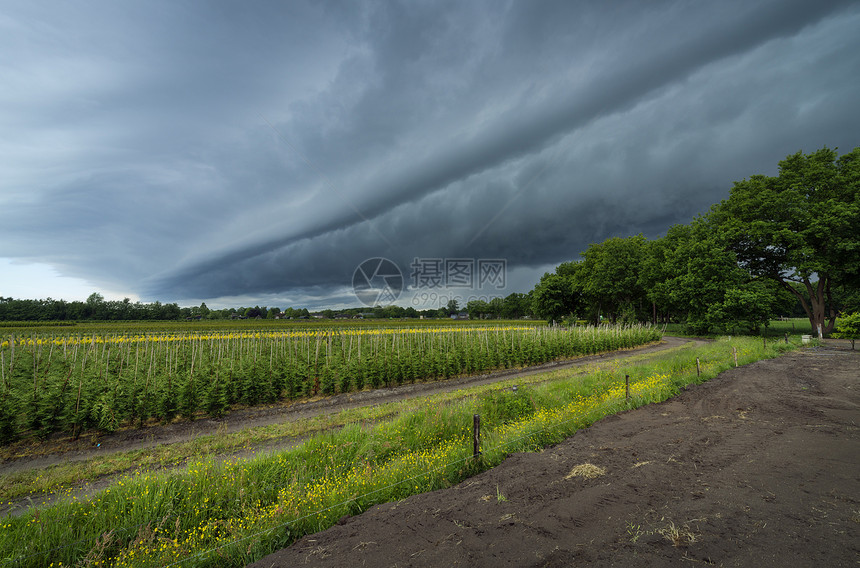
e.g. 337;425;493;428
709;147;860;335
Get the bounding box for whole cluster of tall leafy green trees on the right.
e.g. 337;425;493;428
532;147;860;334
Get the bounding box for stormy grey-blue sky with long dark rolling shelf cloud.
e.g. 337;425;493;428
0;0;860;309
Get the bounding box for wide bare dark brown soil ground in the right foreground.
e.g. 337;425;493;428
252;344;860;568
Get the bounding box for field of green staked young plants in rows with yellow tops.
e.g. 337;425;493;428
0;323;660;443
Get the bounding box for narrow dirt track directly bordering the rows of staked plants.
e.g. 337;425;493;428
0;336;704;474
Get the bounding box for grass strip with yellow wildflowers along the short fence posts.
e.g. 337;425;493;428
0;338;792;566
